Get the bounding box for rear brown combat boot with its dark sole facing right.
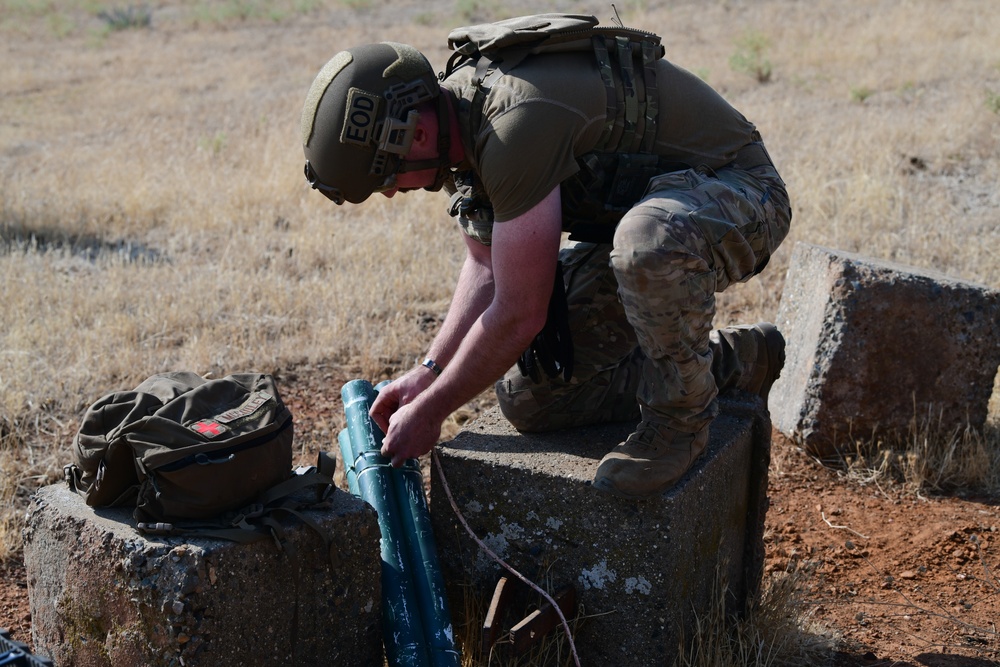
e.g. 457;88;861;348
709;322;785;403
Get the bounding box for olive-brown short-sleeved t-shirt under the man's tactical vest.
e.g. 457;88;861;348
442;52;754;222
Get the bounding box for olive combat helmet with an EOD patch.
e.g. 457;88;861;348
302;42;449;204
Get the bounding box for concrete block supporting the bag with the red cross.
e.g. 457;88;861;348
24;484;383;667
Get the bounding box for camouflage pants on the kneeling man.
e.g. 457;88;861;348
496;160;791;432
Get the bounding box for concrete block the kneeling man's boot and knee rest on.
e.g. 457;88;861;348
431;397;771;667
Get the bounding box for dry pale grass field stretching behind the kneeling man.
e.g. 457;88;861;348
0;0;1000;664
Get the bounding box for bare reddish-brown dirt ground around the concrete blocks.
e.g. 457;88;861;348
0;365;1000;667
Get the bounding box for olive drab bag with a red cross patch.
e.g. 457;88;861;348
65;372;293;522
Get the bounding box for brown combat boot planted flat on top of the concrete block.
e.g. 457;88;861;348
594;421;708;498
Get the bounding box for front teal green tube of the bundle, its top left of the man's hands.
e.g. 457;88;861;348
341;380;430;667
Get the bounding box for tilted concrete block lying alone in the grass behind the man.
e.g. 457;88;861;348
770;243;1000;457
